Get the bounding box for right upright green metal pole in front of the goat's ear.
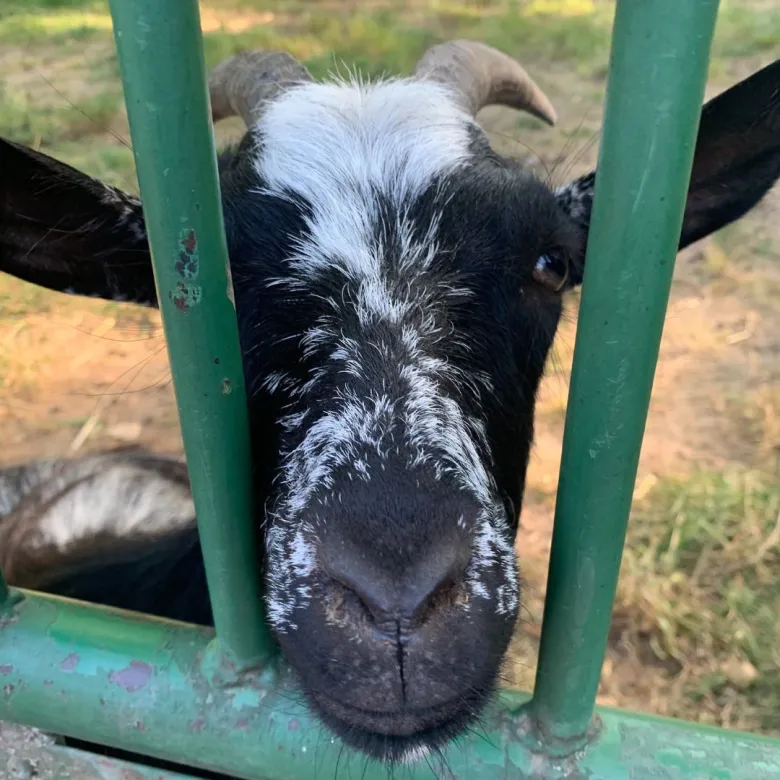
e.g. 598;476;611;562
531;0;718;748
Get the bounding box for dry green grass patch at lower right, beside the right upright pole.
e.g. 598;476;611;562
616;470;780;735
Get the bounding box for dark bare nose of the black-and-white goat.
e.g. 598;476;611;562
327;544;470;633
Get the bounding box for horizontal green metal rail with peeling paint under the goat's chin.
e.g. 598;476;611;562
0;592;780;780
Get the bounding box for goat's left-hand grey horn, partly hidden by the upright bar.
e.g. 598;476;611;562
209;51;312;127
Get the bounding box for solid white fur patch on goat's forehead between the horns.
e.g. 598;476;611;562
255;80;473;284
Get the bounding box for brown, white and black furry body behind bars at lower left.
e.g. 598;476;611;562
0;448;204;624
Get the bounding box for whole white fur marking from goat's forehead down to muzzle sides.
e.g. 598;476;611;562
253;80;517;631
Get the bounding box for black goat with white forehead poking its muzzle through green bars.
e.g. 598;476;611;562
0;41;780;762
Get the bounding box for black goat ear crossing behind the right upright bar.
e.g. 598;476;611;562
556;60;780;281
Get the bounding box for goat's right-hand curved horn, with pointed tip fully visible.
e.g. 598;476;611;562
414;41;557;125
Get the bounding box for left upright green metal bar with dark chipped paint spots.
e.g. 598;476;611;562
106;0;271;665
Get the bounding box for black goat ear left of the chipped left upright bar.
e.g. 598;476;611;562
0;139;157;305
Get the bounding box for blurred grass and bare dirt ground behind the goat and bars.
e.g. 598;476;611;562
0;0;780;735
